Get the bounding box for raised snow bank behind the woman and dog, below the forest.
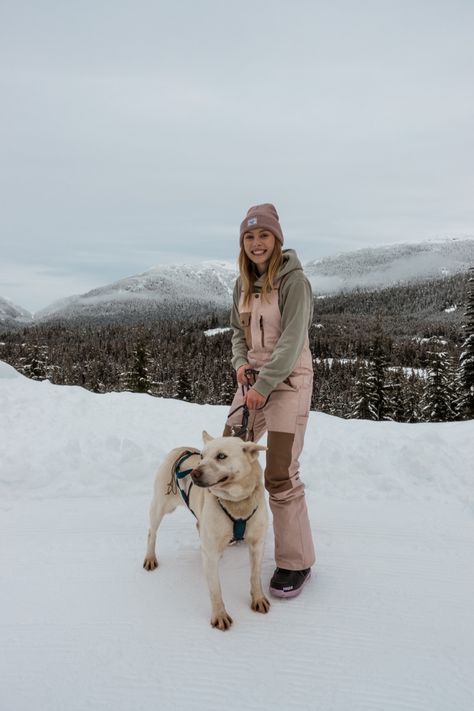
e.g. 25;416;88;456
0;364;474;504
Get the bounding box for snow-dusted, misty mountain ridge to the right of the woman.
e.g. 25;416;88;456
305;239;474;294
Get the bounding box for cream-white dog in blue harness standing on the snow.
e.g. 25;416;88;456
143;432;270;630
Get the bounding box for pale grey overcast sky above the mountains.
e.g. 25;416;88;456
0;0;474;311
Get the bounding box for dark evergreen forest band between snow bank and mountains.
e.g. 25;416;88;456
0;276;474;422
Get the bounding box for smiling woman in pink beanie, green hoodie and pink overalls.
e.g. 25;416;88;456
224;203;315;597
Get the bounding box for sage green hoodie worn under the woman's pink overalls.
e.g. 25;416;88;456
230;249;313;397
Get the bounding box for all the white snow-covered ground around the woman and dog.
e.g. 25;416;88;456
0;363;474;711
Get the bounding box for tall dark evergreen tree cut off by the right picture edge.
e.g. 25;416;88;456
457;267;474;420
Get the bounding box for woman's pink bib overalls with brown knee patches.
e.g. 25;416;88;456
224;286;315;570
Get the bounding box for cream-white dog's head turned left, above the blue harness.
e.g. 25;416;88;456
191;432;266;498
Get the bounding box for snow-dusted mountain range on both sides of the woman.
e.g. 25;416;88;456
0;239;474;326
